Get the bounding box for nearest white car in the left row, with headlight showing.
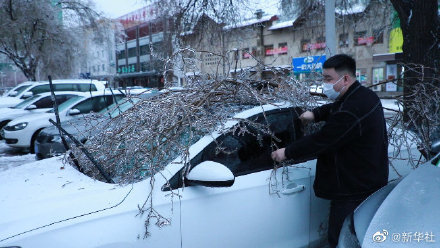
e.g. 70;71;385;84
2;90;124;153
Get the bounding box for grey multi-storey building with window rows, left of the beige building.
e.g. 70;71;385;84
115;5;172;88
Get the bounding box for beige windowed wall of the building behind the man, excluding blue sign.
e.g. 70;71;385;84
182;1;398;94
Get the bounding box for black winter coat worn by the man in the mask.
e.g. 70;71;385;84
285;81;388;200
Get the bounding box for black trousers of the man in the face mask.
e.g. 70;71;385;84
328;199;364;248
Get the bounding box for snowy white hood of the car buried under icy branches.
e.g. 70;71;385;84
0;157;160;246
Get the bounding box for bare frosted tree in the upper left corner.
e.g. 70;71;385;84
0;0;108;81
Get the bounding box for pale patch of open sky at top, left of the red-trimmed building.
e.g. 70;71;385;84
92;0;146;18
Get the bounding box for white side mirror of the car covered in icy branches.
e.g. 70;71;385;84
186;161;235;187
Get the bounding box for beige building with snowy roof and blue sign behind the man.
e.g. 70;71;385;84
179;0;402;94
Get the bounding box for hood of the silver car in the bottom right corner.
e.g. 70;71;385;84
362;163;440;247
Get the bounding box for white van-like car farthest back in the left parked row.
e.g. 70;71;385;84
0;79;106;108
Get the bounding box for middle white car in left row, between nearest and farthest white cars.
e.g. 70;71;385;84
0;91;82;134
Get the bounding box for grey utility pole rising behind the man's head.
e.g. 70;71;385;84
325;0;336;58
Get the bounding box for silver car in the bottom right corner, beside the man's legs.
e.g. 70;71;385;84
338;146;440;248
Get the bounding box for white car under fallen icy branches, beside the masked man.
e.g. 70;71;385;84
0;105;420;248
